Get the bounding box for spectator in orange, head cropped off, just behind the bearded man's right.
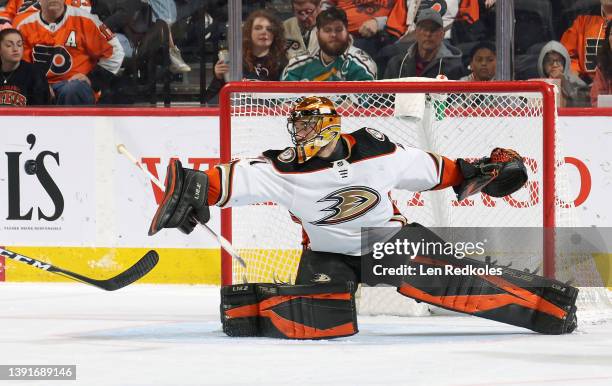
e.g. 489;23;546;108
326;0;396;57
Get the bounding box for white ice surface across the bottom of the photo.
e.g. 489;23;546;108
0;283;612;386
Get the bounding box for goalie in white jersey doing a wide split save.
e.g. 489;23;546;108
149;97;578;339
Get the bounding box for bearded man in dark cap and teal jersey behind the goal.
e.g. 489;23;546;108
282;8;376;81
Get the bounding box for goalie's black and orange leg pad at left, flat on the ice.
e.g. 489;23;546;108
221;282;358;339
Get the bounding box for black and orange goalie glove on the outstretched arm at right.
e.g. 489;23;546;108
453;147;527;201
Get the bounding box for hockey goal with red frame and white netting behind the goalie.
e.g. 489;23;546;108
220;79;611;315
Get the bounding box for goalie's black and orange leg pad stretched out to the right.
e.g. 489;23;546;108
398;225;578;334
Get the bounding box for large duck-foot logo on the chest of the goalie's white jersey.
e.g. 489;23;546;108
311;186;380;225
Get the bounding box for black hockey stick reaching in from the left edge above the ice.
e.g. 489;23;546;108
0;248;159;291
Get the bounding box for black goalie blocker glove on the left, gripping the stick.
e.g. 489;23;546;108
149;160;210;236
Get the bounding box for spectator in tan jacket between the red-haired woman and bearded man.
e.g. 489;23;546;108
283;0;321;59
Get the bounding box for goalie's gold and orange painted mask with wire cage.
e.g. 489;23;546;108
287;97;340;163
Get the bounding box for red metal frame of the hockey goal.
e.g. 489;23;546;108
219;81;557;285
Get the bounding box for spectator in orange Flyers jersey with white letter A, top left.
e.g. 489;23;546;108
17;0;124;105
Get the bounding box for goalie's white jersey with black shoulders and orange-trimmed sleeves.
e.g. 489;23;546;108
209;128;462;256
